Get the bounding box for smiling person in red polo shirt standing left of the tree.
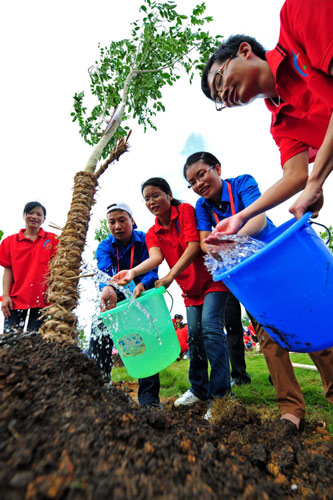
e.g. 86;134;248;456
0;201;58;333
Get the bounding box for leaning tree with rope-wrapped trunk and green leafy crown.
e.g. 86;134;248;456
41;0;220;341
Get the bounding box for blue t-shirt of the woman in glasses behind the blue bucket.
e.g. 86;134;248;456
195;174;275;240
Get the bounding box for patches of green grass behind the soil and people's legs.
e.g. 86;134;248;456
112;351;333;434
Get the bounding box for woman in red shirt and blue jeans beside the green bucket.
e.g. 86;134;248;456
114;177;231;419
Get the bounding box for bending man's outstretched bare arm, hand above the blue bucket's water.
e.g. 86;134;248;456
206;151;308;234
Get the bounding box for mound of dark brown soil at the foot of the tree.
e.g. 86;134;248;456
0;334;333;500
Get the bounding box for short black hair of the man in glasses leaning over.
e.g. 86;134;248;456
201;35;266;99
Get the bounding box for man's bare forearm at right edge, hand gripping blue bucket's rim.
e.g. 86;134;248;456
289;113;333;219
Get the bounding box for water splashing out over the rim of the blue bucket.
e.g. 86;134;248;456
204;233;266;276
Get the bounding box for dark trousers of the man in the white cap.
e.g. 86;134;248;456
88;323;160;405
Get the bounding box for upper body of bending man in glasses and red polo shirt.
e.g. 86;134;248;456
201;0;333;230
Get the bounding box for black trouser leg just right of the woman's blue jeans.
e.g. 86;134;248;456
224;292;251;382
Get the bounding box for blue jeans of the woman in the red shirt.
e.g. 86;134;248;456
186;292;231;400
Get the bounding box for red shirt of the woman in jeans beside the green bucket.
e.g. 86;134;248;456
146;203;228;307
